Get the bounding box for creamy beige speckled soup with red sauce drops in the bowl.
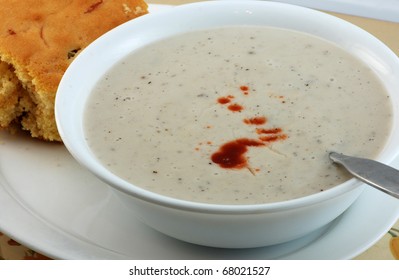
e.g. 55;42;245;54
85;26;392;204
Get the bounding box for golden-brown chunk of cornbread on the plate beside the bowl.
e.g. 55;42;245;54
0;0;148;141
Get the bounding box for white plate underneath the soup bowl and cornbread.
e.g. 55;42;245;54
0;3;399;259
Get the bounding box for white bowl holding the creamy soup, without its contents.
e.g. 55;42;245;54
55;1;399;248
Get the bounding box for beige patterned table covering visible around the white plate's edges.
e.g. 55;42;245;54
0;0;399;260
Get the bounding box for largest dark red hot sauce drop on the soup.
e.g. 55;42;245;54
211;138;265;169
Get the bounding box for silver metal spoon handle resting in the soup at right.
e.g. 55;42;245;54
329;152;399;198
